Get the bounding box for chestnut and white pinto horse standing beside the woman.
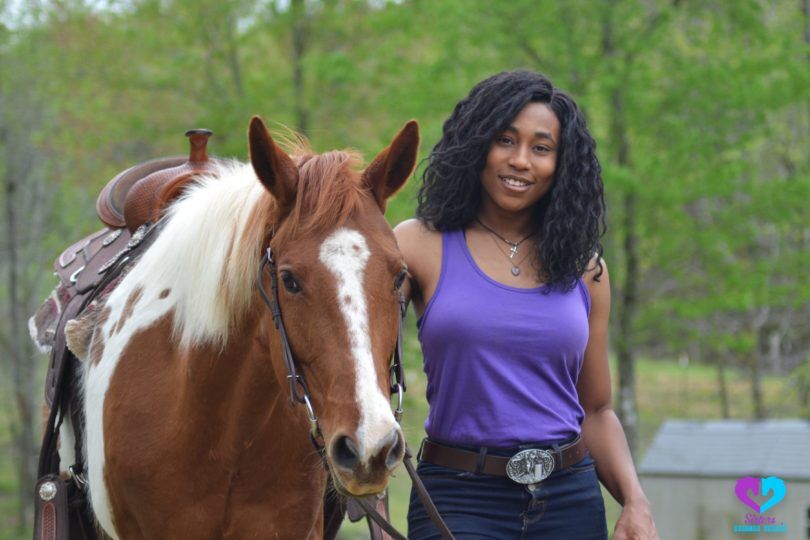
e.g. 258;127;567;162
60;117;419;539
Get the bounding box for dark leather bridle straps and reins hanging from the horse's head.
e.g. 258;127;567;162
256;247;454;540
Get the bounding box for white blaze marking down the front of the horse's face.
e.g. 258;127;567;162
319;228;398;459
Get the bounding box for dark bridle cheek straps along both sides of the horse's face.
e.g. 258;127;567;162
256;247;406;457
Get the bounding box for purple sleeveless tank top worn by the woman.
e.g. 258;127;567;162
418;230;590;448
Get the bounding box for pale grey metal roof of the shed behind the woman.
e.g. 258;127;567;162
639;420;810;480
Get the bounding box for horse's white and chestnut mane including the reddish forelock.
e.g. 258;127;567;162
133;145;364;348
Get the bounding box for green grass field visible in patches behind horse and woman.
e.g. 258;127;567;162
0;336;799;540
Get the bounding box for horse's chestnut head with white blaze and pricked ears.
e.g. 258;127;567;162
249;117;419;495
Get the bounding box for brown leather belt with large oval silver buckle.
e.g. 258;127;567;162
419;436;588;484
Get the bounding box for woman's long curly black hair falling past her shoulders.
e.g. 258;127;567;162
416;70;606;290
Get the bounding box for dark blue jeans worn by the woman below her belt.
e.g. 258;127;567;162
408;450;608;540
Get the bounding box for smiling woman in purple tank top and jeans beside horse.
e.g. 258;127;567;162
395;71;657;539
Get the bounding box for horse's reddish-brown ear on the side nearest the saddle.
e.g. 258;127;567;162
248;116;298;208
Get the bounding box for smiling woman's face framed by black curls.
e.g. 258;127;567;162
481;102;560;218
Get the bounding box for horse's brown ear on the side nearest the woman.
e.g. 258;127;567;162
363;120;419;212
